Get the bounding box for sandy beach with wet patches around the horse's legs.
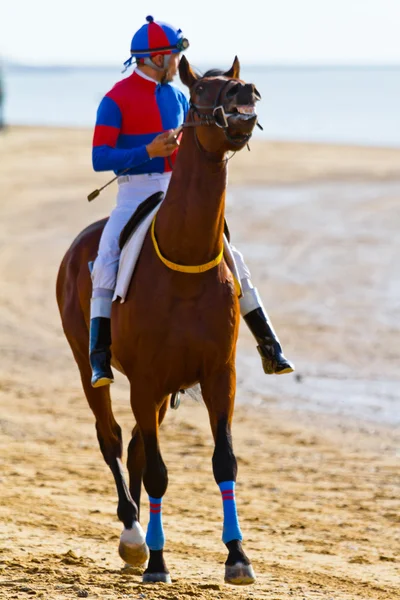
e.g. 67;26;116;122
0;127;400;600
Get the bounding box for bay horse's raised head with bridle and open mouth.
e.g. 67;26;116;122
179;56;261;153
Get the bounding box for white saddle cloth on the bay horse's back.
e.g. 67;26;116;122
113;200;242;302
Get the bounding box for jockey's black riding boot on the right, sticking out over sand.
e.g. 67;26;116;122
243;307;294;375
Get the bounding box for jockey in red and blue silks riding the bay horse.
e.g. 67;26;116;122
90;16;294;387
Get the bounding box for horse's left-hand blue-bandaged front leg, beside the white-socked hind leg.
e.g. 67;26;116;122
131;388;171;583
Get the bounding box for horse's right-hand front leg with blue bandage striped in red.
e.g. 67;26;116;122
201;363;255;585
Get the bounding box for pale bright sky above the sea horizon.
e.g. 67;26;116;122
0;0;400;66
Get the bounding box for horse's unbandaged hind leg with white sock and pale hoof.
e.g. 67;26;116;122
67;328;148;566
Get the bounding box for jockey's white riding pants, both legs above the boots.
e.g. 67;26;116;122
92;173;261;316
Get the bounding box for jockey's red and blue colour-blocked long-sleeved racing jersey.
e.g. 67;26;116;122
92;71;188;175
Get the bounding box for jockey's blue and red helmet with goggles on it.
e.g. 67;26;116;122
124;16;189;68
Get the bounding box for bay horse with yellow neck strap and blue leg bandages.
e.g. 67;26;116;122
57;57;260;584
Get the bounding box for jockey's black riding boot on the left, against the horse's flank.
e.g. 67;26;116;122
89;317;114;387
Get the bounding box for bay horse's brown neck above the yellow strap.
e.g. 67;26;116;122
156;130;226;265
